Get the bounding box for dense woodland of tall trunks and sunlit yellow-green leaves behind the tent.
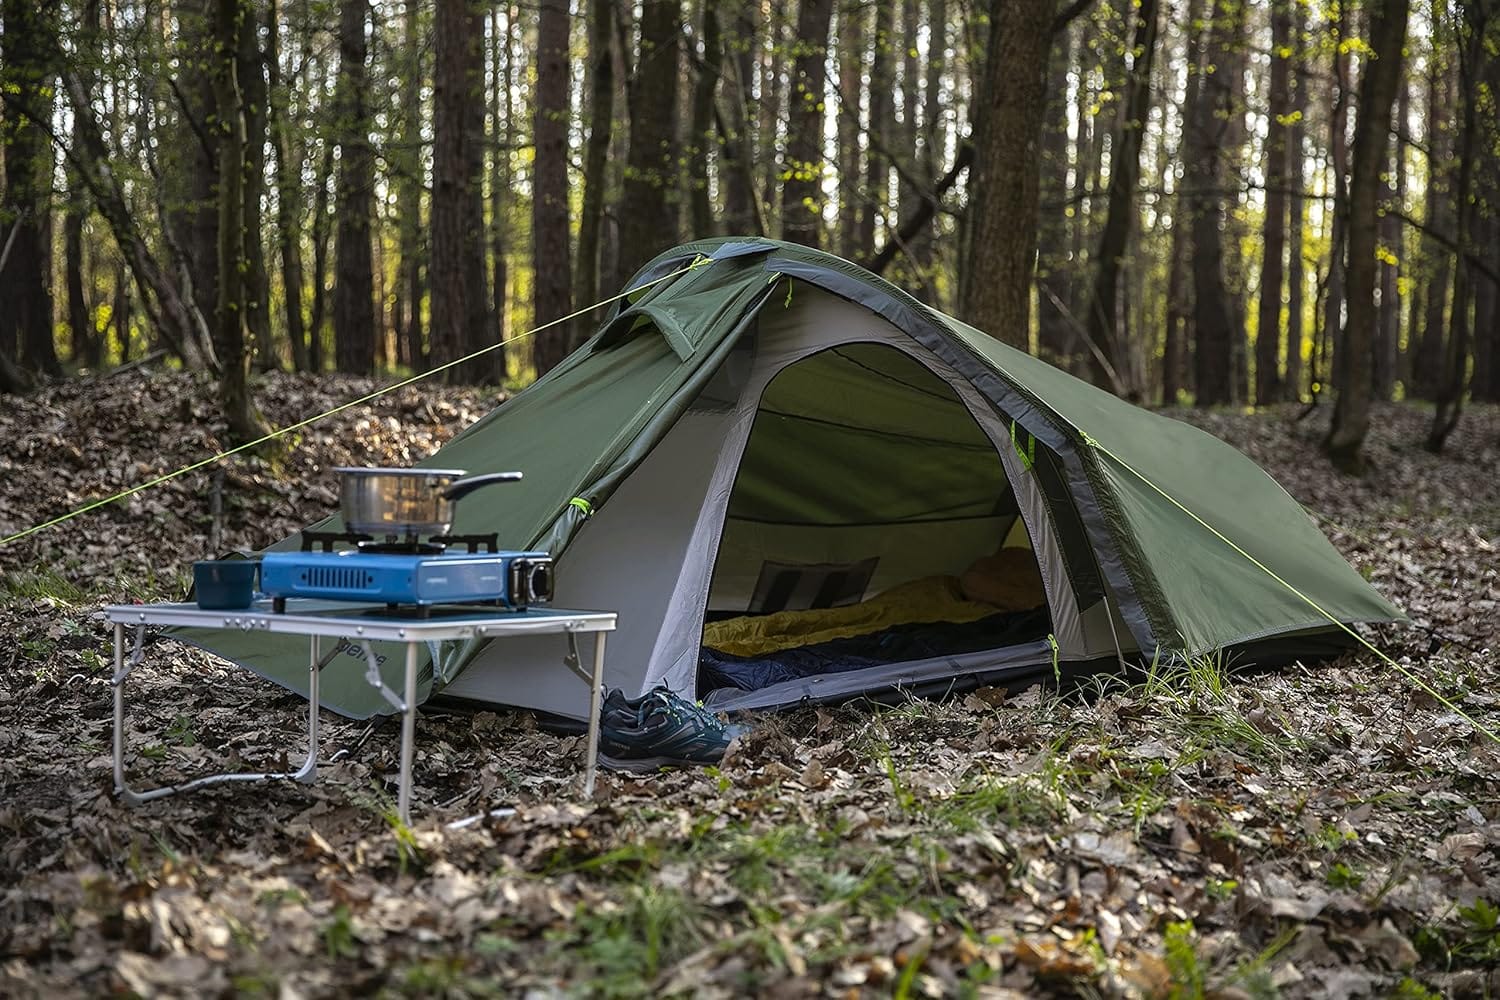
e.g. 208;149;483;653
0;0;1500;471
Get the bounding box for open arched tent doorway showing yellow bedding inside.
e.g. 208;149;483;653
699;342;1052;693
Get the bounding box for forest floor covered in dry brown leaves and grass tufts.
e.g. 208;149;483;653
0;372;1500;997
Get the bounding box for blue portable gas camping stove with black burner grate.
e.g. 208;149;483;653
261;531;552;618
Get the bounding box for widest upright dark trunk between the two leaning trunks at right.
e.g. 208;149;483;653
1182;0;1241;406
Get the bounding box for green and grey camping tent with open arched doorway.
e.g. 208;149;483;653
182;238;1403;718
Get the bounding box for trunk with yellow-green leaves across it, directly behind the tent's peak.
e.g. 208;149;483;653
782;0;840;246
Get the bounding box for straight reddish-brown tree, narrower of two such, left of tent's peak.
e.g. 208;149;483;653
531;0;570;375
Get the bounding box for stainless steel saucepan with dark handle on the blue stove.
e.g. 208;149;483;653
333;468;521;541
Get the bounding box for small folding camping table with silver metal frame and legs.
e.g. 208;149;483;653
104;600;615;823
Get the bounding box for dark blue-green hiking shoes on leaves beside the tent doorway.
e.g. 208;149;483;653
599;687;749;774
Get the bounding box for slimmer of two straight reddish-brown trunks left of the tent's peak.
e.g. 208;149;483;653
531;0;570;376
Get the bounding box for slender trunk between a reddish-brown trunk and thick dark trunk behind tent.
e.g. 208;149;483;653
578;0;618;328
